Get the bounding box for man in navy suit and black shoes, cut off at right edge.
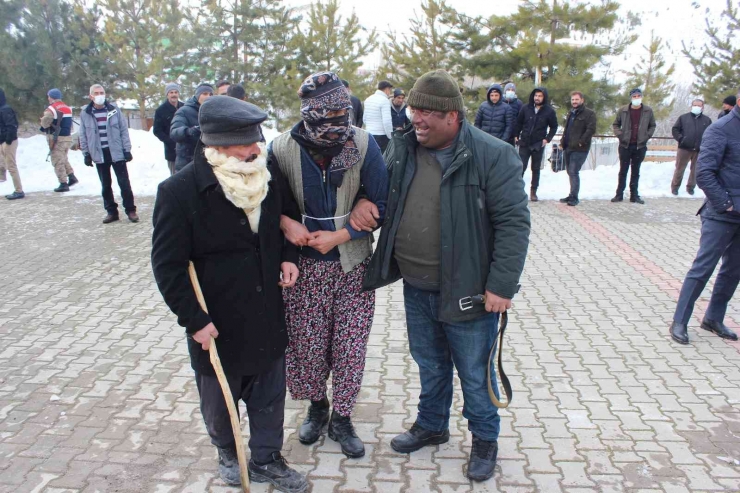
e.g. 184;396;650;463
670;89;740;344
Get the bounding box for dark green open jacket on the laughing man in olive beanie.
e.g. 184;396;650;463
364;117;530;323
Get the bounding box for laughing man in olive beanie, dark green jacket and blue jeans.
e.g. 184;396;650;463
360;70;530;481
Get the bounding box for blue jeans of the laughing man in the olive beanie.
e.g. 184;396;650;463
403;283;501;442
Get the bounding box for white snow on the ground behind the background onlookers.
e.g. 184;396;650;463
0;127;704;200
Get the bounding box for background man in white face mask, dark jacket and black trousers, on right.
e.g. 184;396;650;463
612;88;656;204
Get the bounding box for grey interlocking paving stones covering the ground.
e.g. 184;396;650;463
0;194;740;493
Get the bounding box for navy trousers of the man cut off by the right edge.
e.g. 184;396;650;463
673;217;740;324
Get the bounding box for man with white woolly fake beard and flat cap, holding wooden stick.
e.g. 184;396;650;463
152;97;308;493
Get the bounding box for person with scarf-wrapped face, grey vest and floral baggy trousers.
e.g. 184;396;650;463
270;72;388;457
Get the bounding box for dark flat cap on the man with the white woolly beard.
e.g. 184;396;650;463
196;96;267;146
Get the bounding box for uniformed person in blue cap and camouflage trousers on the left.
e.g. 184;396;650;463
41;89;79;192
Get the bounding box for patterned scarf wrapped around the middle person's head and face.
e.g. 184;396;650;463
297;72;361;187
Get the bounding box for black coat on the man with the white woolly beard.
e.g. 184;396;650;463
152;146;300;375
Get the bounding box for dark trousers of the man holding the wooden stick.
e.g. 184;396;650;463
195;356;285;464
